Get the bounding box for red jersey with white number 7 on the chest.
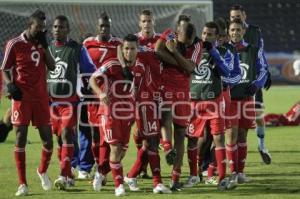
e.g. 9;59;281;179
83;36;121;68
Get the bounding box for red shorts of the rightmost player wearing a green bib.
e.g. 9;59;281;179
229;97;255;129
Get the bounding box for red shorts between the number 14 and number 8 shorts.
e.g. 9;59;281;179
162;86;192;127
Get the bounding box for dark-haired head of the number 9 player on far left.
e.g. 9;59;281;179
28;10;46;37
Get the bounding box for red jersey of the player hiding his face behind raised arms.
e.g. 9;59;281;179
160;29;201;89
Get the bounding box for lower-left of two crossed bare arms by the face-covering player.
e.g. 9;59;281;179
154;39;179;65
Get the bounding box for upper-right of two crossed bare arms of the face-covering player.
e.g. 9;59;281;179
166;40;196;73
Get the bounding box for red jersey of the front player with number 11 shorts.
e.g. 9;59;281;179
93;58;132;115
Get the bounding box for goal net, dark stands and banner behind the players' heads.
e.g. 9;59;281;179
0;0;300;84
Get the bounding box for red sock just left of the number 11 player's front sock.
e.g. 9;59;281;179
98;143;110;175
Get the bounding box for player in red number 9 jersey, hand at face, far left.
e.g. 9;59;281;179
1;10;55;196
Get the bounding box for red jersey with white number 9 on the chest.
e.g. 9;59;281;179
1;33;48;101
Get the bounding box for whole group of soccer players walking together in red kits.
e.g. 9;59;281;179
1;3;271;196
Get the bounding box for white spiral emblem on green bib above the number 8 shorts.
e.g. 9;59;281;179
195;59;211;83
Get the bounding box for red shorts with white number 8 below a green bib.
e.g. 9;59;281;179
187;95;225;137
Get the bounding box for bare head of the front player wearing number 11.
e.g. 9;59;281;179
122;34;138;63
